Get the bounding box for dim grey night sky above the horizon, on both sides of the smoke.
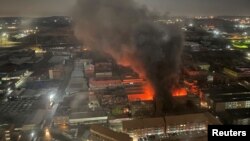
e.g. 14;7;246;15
0;0;250;16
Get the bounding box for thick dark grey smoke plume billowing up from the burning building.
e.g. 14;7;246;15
74;0;182;111
